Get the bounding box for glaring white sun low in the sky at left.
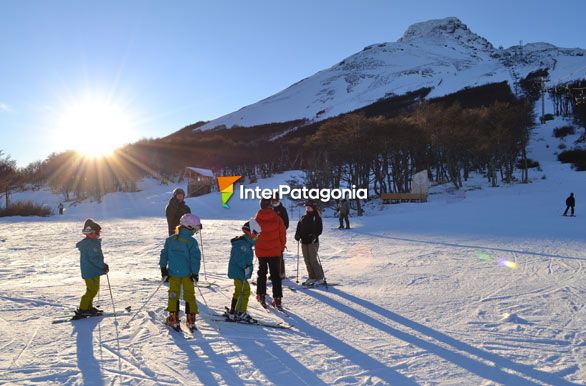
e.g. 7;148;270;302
56;96;134;157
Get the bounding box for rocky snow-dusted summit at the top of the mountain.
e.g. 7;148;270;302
398;17;494;50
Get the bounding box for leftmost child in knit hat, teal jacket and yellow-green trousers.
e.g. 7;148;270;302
75;218;109;317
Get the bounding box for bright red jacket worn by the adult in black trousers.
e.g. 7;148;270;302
254;209;287;257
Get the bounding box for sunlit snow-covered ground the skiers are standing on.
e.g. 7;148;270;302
0;115;586;385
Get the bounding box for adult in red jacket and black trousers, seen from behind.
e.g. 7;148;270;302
254;198;287;309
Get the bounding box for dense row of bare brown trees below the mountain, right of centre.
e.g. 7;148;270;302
305;102;534;195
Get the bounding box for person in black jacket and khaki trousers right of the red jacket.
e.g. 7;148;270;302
295;201;324;286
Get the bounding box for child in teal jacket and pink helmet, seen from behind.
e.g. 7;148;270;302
159;213;201;330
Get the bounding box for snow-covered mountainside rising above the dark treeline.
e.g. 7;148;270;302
196;17;586;130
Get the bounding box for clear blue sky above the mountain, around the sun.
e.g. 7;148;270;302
0;0;586;165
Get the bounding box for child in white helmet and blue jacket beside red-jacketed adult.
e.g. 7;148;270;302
226;219;261;323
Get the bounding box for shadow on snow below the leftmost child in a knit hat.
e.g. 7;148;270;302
73;318;104;385
